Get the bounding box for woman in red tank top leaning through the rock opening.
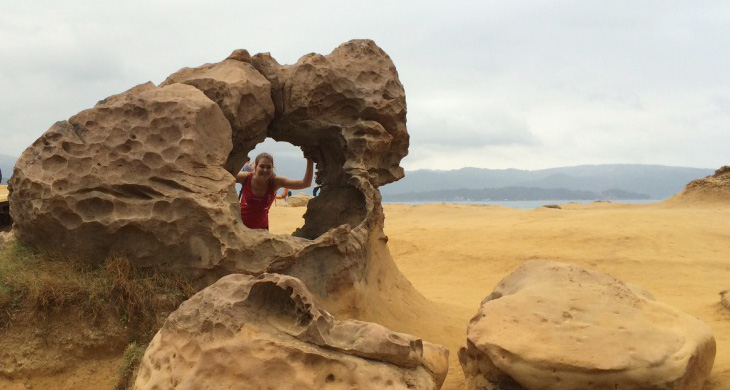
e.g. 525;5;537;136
236;153;314;230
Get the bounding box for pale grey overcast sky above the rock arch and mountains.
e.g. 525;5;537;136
0;0;730;170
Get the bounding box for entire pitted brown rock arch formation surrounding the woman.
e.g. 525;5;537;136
10;40;408;297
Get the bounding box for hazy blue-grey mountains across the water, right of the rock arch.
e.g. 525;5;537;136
380;164;714;202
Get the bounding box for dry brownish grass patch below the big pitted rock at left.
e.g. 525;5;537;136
0;241;195;337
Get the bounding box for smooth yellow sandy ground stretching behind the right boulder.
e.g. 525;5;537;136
271;202;730;390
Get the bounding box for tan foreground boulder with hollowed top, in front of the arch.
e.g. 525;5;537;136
134;274;448;390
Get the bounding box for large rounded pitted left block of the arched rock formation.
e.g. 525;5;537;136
10;83;242;267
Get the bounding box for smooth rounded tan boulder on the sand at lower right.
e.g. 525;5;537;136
459;261;715;390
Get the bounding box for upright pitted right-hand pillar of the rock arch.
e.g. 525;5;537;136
269;40;409;238
